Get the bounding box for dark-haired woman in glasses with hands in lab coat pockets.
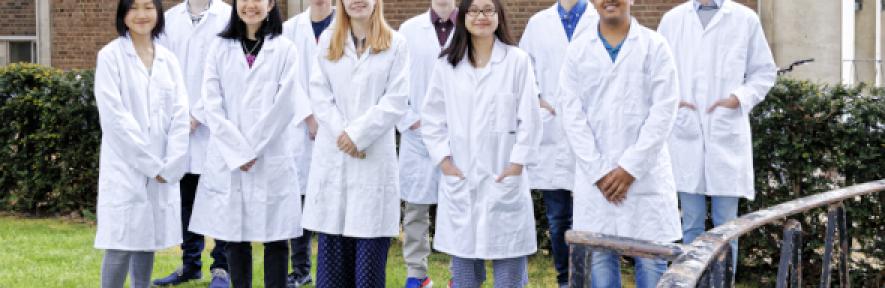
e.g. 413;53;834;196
421;0;541;288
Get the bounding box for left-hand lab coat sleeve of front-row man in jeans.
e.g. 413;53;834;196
559;46;614;183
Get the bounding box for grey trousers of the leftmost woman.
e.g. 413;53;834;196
101;250;154;288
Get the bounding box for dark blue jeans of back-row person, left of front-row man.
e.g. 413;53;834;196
540;190;572;284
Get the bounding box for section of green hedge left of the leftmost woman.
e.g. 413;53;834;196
0;64;101;215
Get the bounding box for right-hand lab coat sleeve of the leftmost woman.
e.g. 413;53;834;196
160;61;190;183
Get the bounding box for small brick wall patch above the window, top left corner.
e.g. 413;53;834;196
0;0;37;36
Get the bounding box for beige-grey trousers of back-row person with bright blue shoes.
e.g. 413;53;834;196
403;202;433;279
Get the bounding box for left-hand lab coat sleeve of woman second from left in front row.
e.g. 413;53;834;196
201;41;257;170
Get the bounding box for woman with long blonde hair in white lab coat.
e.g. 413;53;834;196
303;0;409;288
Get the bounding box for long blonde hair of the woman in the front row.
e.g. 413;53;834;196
326;0;393;61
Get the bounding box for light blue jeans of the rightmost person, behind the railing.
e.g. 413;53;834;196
679;192;740;271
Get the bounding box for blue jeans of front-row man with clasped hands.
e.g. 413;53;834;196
590;251;667;288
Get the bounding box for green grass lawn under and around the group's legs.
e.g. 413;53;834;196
0;216;588;288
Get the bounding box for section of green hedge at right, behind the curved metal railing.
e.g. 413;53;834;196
739;79;885;287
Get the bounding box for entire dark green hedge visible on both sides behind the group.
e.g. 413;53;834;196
0;64;885;286
